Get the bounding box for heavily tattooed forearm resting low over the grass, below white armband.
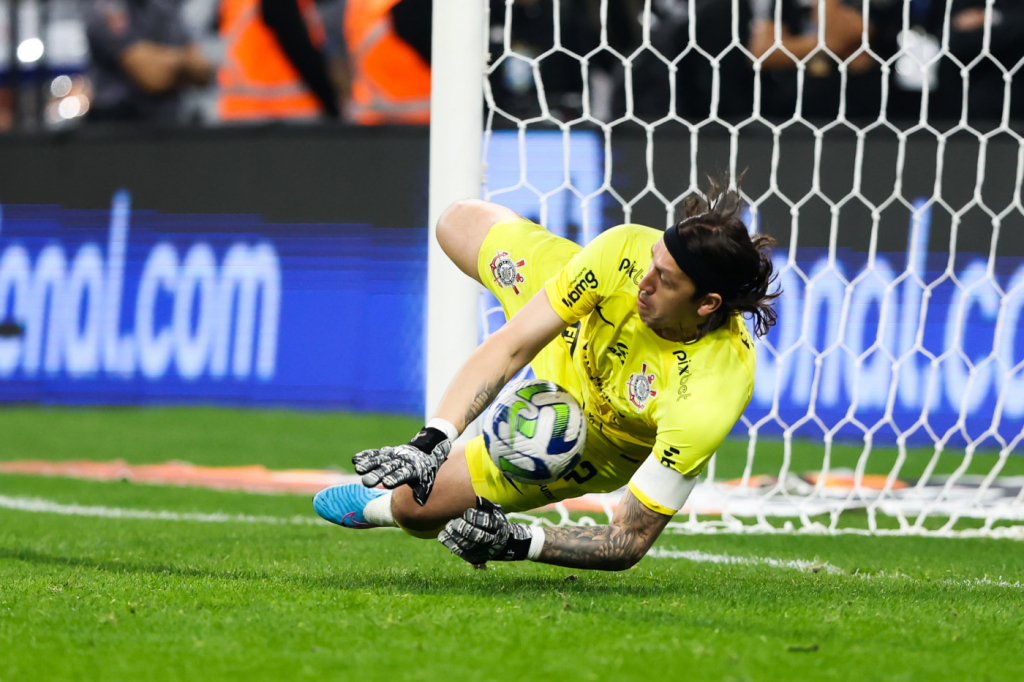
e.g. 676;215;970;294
538;493;672;570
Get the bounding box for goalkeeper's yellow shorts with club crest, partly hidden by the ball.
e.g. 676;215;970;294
466;218;650;511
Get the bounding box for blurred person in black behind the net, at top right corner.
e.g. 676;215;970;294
914;0;1024;123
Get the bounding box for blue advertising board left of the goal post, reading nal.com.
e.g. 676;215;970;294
0;190;426;414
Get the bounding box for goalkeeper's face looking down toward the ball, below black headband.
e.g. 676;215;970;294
637;240;721;340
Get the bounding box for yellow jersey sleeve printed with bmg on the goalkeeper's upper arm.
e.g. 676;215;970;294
544;225;649;325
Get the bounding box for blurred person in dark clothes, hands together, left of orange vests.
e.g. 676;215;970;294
84;0;213;123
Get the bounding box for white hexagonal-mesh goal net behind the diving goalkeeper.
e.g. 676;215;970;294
434;0;1024;537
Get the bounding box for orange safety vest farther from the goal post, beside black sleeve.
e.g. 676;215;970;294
217;0;325;121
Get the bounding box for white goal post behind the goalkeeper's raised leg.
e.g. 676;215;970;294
425;0;485;419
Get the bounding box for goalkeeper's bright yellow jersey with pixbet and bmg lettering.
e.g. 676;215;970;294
545;225;755;475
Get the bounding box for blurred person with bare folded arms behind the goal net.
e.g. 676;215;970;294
749;0;901;120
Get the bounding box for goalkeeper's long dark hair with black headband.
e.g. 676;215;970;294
675;179;782;341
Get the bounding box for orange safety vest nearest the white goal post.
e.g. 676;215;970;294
345;0;430;125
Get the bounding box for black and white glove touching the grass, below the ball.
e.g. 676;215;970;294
437;497;534;564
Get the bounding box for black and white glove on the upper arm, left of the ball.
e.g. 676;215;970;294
352;426;452;507
